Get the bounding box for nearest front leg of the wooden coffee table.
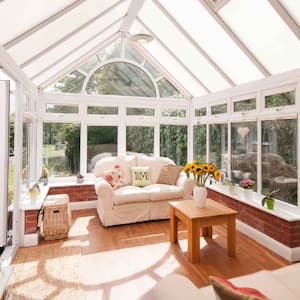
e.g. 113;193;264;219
188;220;200;264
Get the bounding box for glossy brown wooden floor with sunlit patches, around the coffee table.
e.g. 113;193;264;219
52;210;288;300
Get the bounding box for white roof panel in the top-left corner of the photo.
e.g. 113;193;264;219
0;0;76;44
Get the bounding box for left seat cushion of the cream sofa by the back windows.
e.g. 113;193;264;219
112;185;150;205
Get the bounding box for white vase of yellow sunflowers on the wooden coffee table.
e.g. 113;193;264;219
184;160;221;208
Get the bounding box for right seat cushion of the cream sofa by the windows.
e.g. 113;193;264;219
143;183;183;201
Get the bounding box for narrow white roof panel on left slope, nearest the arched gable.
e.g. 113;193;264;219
33;22;121;85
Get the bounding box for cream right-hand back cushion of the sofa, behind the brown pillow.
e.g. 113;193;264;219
136;155;175;183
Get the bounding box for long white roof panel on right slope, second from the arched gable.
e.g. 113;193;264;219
139;1;229;91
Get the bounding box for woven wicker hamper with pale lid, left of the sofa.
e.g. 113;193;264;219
42;194;71;240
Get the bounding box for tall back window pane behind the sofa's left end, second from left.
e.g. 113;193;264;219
87;126;118;172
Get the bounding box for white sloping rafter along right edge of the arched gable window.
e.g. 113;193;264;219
126;33;193;99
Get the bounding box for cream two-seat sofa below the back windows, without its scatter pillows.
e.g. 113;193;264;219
94;155;194;226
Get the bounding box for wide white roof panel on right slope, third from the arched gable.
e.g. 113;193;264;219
160;0;263;84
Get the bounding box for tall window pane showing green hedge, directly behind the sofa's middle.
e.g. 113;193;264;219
126;126;154;156
